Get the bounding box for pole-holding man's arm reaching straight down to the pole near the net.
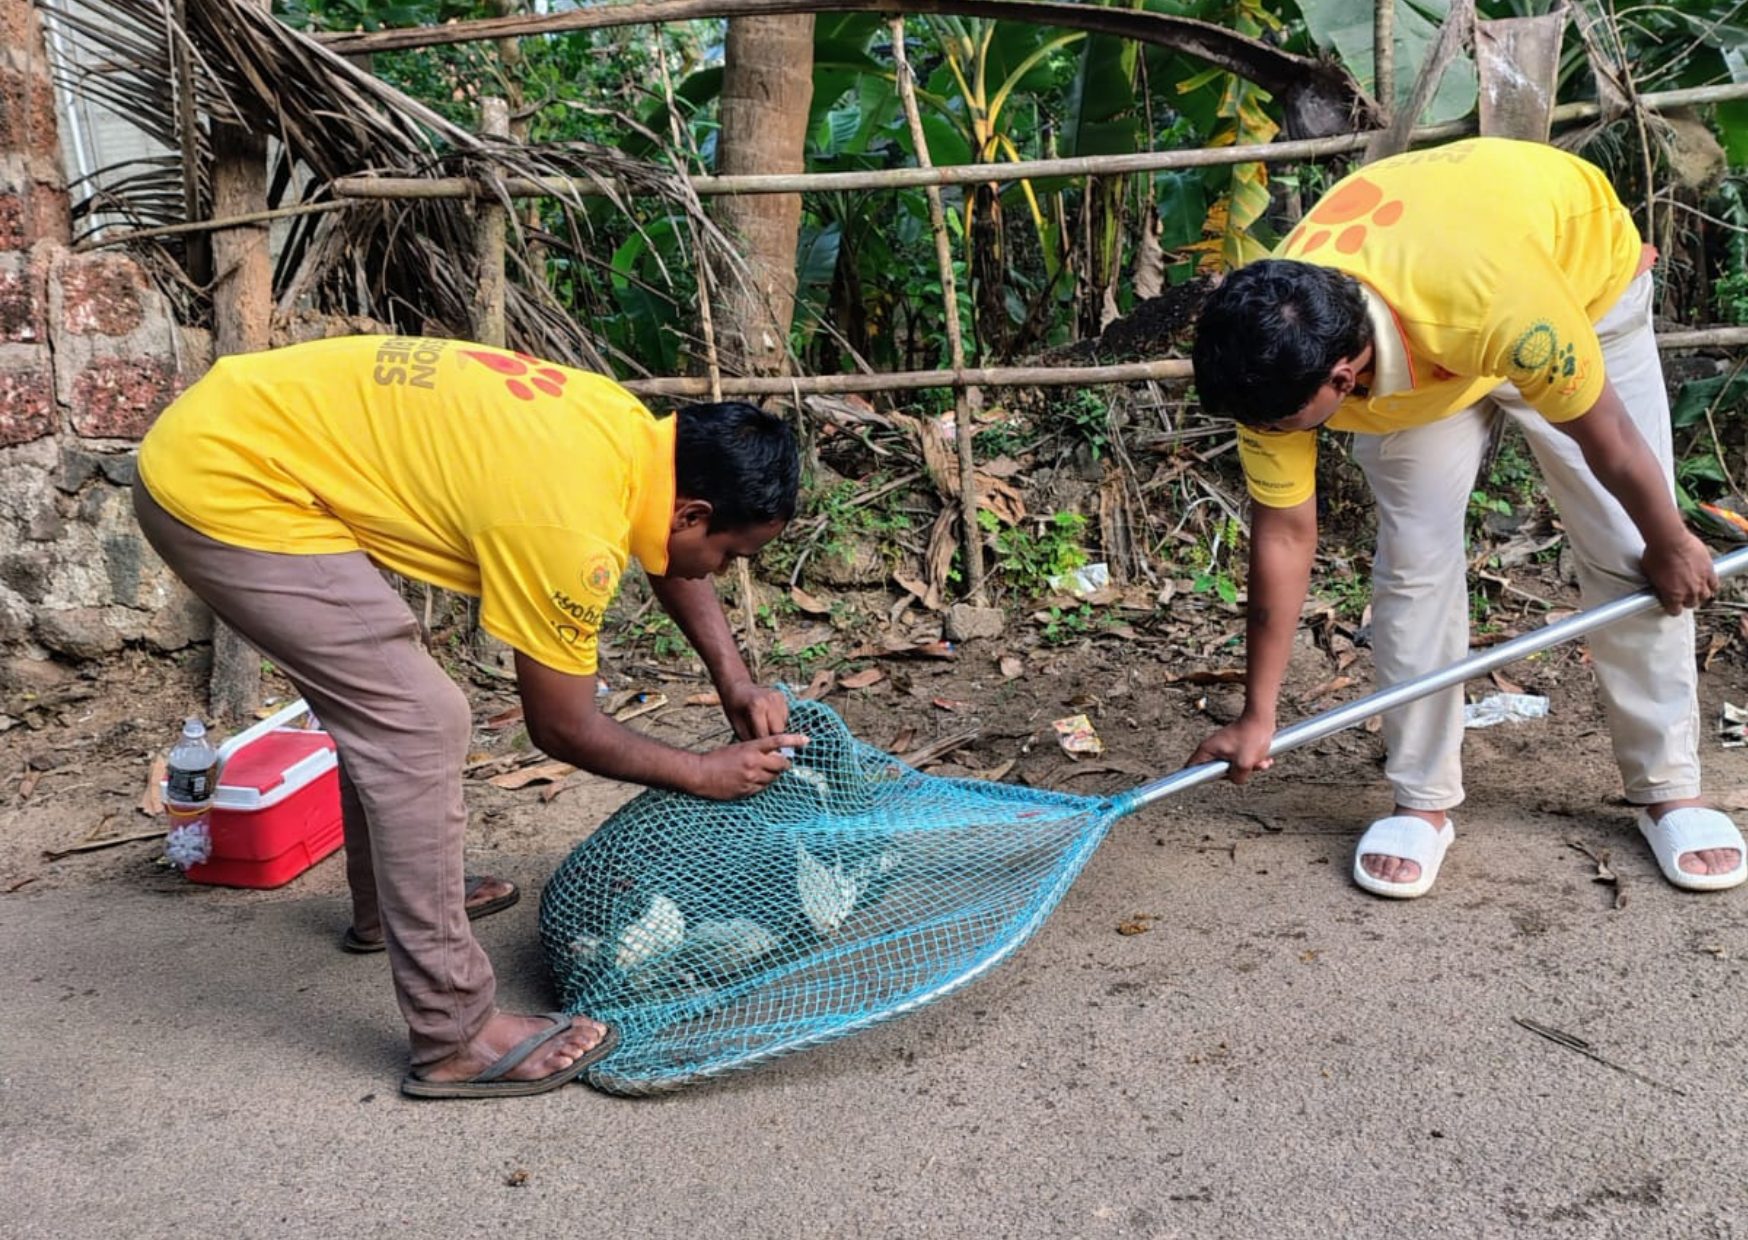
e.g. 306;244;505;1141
1185;498;1316;784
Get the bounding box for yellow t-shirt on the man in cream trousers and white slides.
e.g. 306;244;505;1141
1238;138;1641;507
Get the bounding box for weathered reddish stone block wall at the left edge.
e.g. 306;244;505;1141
0;0;212;680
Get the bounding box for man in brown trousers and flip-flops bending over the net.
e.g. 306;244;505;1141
135;336;806;1098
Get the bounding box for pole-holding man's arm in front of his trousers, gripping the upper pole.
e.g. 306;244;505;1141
1554;374;1718;616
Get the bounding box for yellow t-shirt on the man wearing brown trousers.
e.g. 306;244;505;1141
140;336;675;675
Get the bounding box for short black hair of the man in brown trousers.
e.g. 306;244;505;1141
673;401;801;533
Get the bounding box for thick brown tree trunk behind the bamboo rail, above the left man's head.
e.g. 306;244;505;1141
717;14;813;374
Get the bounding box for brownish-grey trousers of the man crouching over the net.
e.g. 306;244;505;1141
133;481;496;1067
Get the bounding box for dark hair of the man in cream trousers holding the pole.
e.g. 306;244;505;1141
1190;259;1372;427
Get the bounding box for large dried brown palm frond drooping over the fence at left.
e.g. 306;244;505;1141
40;0;741;371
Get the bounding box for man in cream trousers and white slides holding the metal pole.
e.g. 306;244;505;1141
1190;138;1748;897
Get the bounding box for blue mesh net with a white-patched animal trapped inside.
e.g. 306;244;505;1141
540;701;1127;1095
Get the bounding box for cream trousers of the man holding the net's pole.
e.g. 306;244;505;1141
1353;273;1699;810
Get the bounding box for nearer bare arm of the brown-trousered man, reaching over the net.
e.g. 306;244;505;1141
516;651;808;801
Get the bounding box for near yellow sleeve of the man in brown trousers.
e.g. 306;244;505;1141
474;525;626;675
